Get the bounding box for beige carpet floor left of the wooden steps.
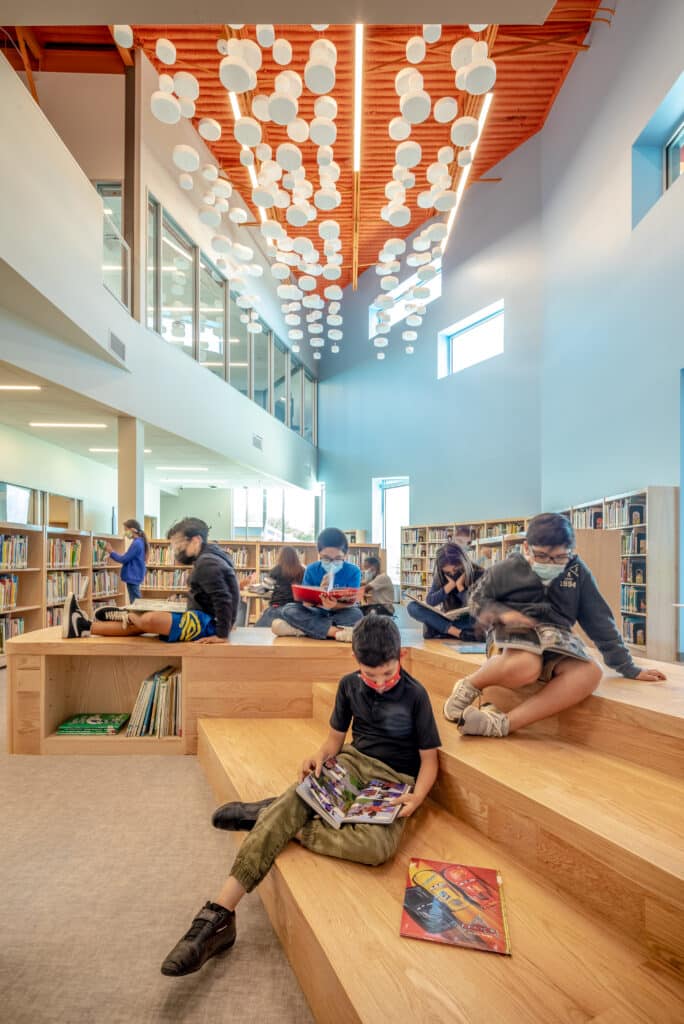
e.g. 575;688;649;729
0;672;311;1024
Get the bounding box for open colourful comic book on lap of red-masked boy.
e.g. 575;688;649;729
297;758;411;828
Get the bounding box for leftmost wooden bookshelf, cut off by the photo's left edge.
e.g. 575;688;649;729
0;522;45;668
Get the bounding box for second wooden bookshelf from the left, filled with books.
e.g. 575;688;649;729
45;526;92;626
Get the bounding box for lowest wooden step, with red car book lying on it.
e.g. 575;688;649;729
199;719;682;1024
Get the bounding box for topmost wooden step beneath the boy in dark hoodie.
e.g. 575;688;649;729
407;640;684;778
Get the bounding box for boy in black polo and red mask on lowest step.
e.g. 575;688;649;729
162;615;440;977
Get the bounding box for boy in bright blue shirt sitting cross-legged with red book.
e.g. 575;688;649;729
270;526;364;643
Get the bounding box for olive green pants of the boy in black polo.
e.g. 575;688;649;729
230;744;414;893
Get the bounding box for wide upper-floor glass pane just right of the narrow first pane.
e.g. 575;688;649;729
162;214;195;355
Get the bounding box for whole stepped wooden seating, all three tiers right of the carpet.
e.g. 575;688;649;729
199;643;684;1024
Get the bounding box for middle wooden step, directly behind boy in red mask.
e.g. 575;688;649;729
313;684;684;970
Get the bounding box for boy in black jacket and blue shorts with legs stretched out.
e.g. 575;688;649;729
62;516;240;643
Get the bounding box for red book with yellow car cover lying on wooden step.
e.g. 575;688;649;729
399;859;511;955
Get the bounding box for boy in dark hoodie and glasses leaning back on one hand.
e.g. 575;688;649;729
444;513;666;736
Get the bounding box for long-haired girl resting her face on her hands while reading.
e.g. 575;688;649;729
407;541;484;640
